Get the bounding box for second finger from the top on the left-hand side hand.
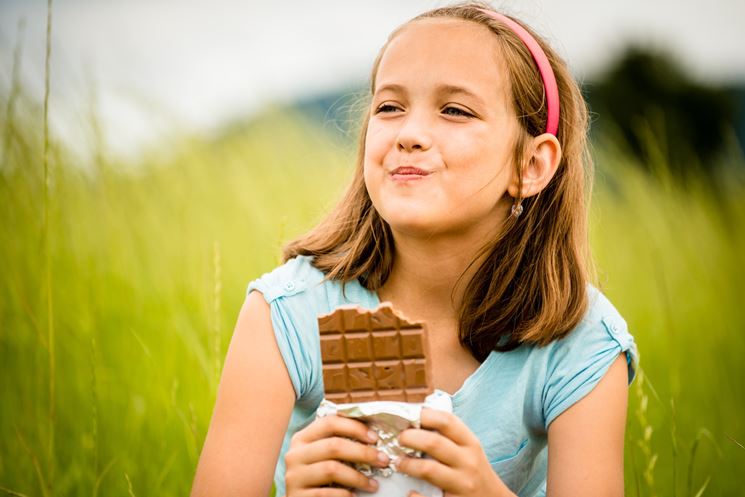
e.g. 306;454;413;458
294;437;390;468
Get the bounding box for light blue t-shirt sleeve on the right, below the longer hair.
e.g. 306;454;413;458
542;297;639;429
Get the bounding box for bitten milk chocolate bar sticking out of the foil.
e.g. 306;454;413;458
318;303;433;403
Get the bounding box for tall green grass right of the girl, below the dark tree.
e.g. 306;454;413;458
592;147;745;496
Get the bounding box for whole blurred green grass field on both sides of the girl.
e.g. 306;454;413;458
0;91;745;497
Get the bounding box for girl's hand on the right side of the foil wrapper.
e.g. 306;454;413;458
398;408;515;497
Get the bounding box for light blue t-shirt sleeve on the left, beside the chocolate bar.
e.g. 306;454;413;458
246;260;320;399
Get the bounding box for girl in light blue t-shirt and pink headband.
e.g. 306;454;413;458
192;3;638;497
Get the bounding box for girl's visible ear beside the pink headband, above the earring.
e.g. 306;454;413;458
508;133;561;198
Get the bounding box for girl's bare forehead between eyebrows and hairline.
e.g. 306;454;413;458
375;18;508;101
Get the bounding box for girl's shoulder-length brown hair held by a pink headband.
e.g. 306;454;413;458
283;2;592;361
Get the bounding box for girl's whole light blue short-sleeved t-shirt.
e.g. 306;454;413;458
247;256;639;497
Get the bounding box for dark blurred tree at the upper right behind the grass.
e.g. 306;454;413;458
585;47;742;181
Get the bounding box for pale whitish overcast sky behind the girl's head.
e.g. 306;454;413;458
0;0;745;156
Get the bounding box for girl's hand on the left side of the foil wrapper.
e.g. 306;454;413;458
285;416;389;497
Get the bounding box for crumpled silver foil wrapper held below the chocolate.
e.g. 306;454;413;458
316;390;453;497
